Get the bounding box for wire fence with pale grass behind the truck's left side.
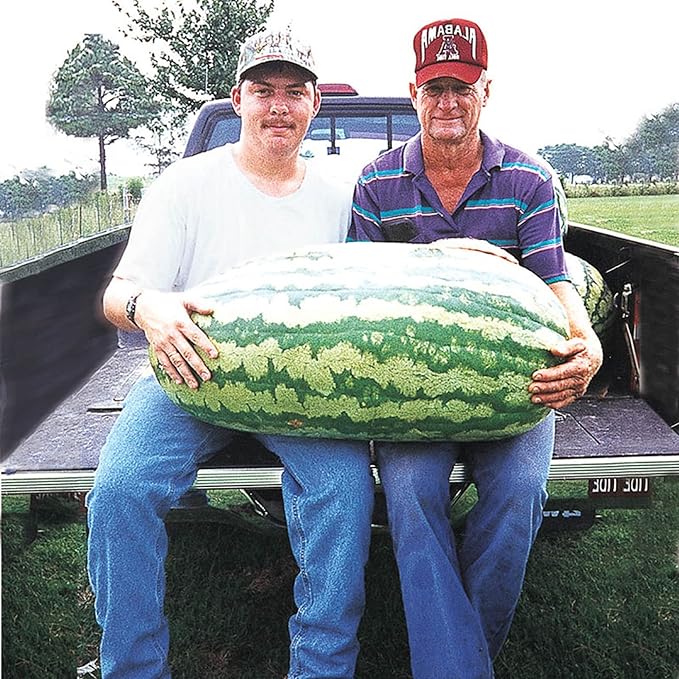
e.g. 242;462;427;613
0;192;135;270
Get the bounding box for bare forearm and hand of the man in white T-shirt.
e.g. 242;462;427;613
103;277;217;389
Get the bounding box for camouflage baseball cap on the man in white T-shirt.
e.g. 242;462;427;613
236;27;318;82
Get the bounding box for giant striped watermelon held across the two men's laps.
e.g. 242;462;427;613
151;243;568;441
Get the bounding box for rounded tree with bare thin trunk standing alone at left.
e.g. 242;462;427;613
46;33;158;191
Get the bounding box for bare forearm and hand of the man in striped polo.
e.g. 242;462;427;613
528;281;603;409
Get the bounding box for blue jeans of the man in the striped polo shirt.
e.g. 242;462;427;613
377;413;554;679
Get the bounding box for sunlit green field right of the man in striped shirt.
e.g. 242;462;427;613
568;195;679;247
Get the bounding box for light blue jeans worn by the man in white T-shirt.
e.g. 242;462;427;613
87;376;374;679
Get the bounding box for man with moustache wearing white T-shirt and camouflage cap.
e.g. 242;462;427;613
88;26;373;679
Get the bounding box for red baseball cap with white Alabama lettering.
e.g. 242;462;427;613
413;19;488;87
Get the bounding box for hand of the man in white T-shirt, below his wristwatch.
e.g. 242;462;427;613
135;290;218;389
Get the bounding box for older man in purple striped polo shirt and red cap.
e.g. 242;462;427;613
349;19;602;679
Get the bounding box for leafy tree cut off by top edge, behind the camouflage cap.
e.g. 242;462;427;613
112;0;273;119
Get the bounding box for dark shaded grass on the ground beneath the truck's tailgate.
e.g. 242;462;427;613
2;480;679;679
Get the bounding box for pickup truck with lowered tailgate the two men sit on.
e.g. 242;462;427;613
0;85;679;525
